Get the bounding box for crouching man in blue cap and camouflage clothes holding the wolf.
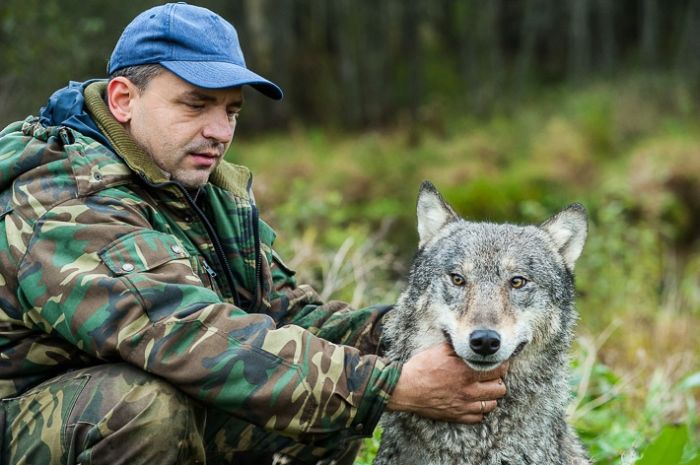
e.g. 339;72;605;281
0;3;505;465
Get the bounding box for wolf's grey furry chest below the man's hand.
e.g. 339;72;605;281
375;376;566;465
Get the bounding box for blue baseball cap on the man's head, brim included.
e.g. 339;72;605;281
107;2;283;100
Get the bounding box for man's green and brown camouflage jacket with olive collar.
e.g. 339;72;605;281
0;84;400;439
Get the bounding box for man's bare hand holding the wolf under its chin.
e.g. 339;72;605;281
387;343;508;423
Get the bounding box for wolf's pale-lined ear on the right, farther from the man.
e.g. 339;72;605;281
540;203;588;270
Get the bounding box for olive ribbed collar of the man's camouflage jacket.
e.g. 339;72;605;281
84;81;253;201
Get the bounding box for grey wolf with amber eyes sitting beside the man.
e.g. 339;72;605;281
374;181;590;465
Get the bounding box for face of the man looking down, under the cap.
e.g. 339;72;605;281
126;71;243;188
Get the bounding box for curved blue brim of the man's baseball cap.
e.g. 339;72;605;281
160;61;284;100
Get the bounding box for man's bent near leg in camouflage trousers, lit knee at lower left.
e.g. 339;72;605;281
2;363;205;465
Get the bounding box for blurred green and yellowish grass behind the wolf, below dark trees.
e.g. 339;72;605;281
230;76;700;465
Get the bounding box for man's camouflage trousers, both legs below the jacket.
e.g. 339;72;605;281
0;363;360;465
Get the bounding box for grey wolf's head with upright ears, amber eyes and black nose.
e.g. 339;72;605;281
394;181;587;370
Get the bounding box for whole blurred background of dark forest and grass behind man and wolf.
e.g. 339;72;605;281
0;0;700;465
